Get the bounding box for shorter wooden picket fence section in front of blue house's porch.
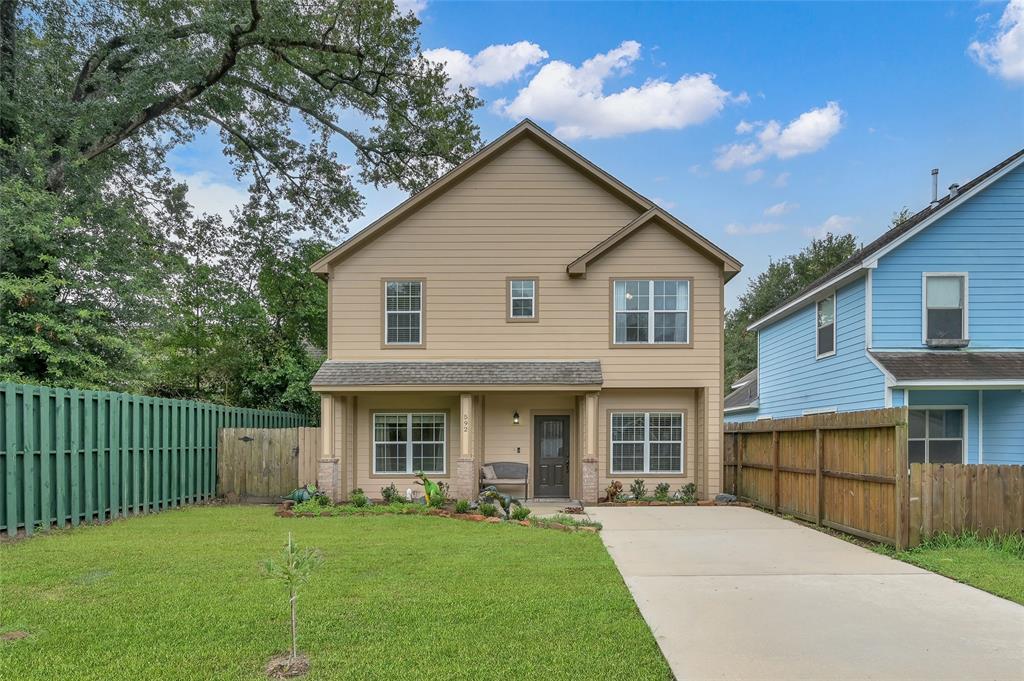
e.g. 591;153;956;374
909;464;1024;546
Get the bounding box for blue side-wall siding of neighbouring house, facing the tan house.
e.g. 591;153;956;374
753;279;885;420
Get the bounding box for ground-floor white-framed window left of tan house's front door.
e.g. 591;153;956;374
374;412;447;475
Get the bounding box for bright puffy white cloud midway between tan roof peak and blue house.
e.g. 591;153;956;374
715;101;846;170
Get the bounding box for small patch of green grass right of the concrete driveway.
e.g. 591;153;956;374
880;534;1024;605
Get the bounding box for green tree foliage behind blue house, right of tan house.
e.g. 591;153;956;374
725;233;857;391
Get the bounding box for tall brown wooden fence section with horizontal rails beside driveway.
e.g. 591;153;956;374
725;408;909;546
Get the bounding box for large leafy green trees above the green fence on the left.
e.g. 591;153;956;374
0;0;480;409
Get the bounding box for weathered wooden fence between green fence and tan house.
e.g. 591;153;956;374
217;428;321;502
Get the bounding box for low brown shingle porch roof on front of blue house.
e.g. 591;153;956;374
871;351;1024;381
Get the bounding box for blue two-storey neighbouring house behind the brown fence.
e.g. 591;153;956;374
725;150;1024;464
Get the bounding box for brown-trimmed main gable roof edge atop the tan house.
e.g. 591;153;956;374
309;119;740;281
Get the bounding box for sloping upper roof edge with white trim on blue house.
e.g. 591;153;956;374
748;148;1024;331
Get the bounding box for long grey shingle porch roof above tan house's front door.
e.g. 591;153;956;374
310;359;604;386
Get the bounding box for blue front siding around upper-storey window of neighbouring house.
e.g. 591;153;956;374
871;163;1024;348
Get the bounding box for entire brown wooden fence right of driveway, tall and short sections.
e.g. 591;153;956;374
723;408;1024;547
